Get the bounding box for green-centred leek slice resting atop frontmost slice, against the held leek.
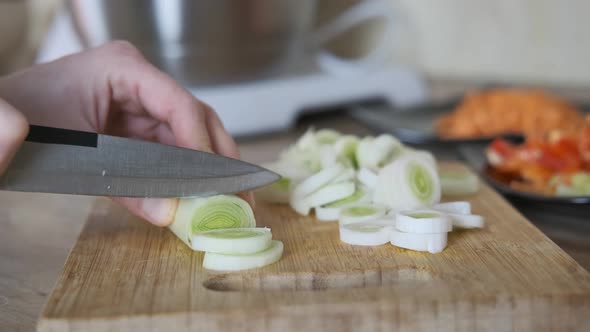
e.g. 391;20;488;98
192;228;272;254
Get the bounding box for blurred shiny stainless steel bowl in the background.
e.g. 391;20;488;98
68;0;316;85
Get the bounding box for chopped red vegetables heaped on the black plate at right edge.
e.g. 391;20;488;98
487;116;590;196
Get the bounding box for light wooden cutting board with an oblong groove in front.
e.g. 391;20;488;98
38;163;590;332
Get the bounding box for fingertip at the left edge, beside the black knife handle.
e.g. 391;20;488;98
0;99;29;174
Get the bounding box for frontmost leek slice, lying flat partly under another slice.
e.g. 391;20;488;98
203;240;283;271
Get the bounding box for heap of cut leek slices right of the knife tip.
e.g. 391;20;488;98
257;129;484;253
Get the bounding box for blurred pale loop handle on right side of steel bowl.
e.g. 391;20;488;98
312;0;398;75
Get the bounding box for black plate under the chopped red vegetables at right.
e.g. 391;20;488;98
481;164;590;207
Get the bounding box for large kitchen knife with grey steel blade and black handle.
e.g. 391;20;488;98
0;125;280;197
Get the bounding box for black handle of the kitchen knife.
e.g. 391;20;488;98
25;125;98;148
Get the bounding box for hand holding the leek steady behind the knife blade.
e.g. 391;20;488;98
0;42;252;226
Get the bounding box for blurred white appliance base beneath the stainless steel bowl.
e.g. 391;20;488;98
37;8;427;136
